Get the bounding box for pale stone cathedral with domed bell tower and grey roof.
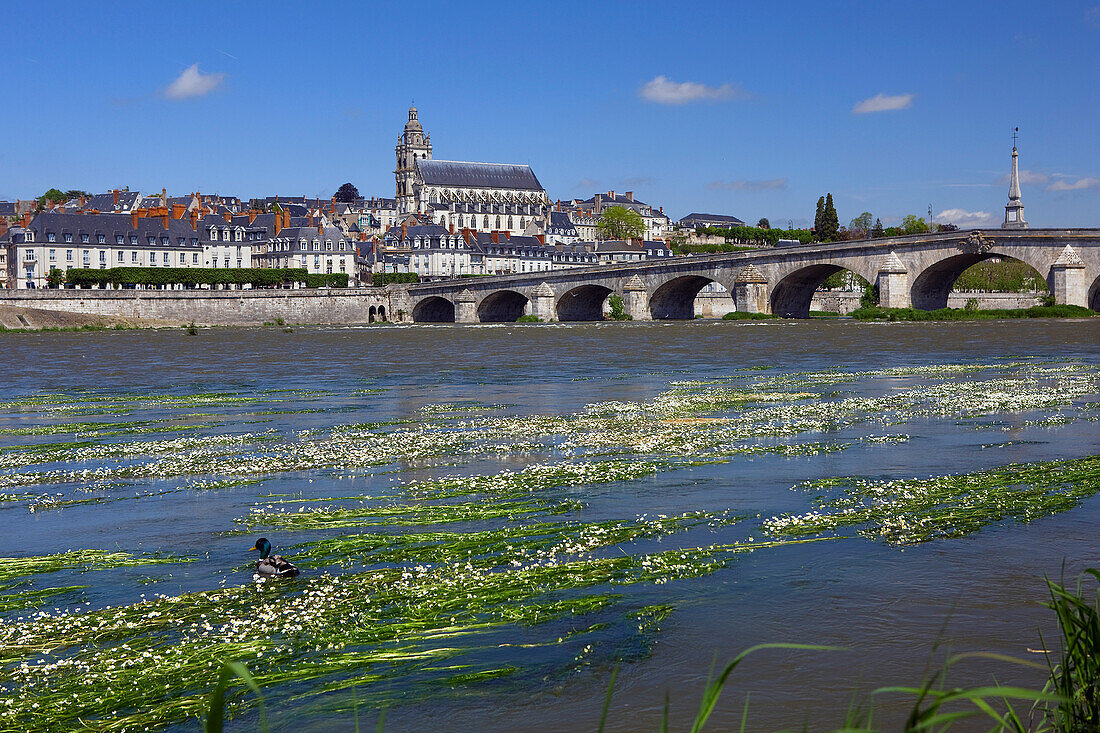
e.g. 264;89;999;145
394;107;550;234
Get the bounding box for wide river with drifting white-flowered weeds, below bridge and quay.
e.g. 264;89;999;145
0;318;1100;731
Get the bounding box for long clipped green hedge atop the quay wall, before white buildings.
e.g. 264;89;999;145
65;267;310;287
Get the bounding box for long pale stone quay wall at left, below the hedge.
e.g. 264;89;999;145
0;286;408;326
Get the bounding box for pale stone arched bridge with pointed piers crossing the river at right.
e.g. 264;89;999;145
394;229;1100;324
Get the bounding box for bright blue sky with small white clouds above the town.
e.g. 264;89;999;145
0;0;1100;227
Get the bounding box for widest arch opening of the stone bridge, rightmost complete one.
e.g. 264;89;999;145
912;252;1049;310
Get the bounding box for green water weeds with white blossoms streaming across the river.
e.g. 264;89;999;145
0;359;1100;731
